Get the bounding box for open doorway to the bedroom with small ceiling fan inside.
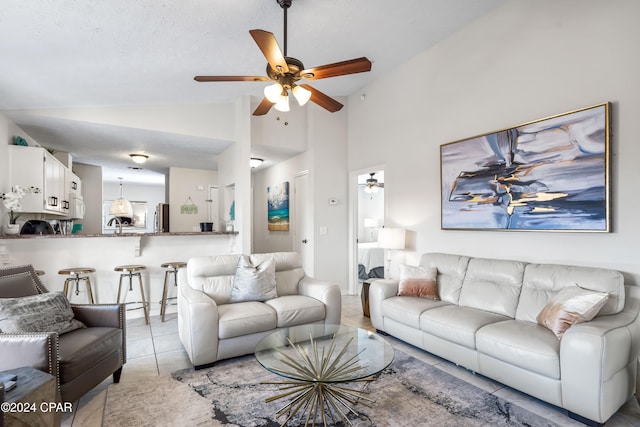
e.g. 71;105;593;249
349;165;386;295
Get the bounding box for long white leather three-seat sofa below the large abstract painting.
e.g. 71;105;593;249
369;253;640;425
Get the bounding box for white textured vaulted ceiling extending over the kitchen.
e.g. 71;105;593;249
0;0;506;181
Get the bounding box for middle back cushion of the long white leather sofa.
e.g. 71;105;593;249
459;258;525;318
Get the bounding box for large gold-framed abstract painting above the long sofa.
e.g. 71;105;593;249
440;103;610;232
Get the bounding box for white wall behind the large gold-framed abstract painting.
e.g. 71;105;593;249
348;0;640;283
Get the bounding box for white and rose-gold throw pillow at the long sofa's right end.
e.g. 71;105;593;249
537;285;609;339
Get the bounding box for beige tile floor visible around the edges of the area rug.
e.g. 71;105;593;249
62;295;640;427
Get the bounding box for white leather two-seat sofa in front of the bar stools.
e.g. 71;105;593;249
178;252;342;368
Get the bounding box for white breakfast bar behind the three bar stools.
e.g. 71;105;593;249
0;231;238;318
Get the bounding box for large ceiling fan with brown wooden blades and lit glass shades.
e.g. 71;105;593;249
194;0;371;116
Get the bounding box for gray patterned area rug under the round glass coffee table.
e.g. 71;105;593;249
103;350;556;427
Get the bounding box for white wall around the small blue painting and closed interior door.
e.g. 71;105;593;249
253;100;349;293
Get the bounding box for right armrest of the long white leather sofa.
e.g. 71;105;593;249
560;286;640;422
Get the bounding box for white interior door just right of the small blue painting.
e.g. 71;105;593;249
293;171;314;276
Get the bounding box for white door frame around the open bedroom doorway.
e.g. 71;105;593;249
348;164;388;295
